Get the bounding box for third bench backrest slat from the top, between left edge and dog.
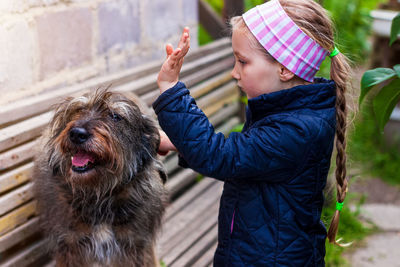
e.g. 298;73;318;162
0;141;37;171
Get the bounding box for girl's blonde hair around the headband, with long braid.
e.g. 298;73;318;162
231;0;351;245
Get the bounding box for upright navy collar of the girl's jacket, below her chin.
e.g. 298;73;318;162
248;78;336;119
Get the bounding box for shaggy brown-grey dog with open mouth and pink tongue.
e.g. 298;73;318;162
34;90;166;267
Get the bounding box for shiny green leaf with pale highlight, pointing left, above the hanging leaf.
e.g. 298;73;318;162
359;68;396;105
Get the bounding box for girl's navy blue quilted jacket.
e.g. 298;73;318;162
153;79;336;267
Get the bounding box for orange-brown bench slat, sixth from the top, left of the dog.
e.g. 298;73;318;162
0;200;36;236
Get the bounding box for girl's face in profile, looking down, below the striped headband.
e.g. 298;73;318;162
231;29;285;99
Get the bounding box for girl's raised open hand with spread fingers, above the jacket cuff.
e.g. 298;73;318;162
157;27;190;93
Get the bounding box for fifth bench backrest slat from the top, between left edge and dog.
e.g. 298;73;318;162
0;183;33;216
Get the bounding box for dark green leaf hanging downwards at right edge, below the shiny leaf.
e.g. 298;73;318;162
373;79;400;131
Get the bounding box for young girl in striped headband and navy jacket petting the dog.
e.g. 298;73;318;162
153;0;349;266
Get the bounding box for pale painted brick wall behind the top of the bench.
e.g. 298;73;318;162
0;0;198;104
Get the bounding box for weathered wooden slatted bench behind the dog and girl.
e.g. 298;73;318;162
0;39;241;267
